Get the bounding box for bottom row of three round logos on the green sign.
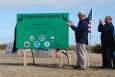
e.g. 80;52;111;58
24;41;50;48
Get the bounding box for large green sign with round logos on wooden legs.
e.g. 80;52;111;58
16;13;68;48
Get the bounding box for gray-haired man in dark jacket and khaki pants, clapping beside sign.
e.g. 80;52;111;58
68;12;89;69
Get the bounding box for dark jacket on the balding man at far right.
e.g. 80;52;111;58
98;23;114;47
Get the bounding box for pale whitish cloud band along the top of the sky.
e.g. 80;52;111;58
0;0;115;8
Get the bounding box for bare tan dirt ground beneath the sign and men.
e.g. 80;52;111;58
0;52;115;77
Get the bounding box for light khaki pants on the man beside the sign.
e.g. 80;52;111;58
76;43;88;68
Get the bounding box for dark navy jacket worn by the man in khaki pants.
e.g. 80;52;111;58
71;18;89;44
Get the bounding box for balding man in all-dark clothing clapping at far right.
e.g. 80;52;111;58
98;16;114;68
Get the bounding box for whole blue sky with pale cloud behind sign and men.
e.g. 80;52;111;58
0;0;115;44
